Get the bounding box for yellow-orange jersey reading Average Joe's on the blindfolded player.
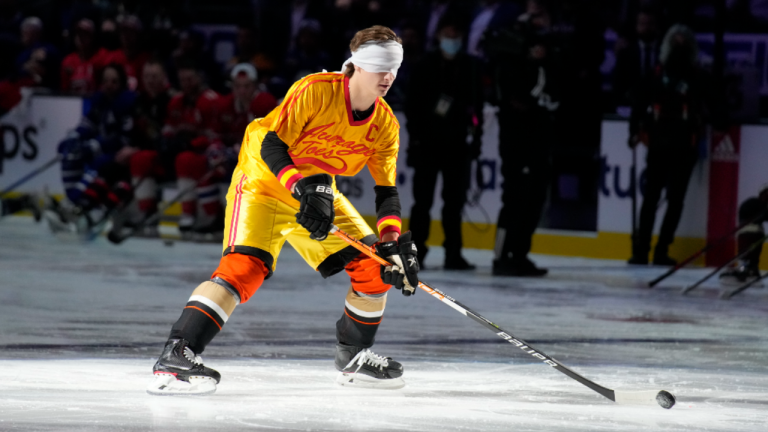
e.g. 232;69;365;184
233;73;400;233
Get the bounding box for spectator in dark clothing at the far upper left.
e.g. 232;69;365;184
15;17;61;89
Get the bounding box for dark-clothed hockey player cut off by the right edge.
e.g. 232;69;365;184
720;184;768;285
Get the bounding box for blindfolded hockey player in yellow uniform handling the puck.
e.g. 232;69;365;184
147;26;419;394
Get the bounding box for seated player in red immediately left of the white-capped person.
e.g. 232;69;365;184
163;63;223;236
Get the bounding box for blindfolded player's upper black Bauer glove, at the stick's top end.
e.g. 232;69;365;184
293;174;336;241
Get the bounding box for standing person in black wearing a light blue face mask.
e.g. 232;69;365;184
405;17;483;270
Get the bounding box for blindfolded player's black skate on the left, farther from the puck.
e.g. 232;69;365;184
147;339;221;396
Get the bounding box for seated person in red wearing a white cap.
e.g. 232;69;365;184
216;63;277;148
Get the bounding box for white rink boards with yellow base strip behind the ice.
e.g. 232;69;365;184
0;95;768;268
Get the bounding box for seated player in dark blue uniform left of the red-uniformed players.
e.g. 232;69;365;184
51;64;136;231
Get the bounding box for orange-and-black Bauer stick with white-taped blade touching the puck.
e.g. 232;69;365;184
331;225;675;409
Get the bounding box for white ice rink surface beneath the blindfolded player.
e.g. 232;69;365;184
0;218;768;432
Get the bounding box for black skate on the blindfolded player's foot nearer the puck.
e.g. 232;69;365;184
336;343;405;389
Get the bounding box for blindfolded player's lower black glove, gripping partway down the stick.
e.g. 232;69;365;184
376;231;419;296
